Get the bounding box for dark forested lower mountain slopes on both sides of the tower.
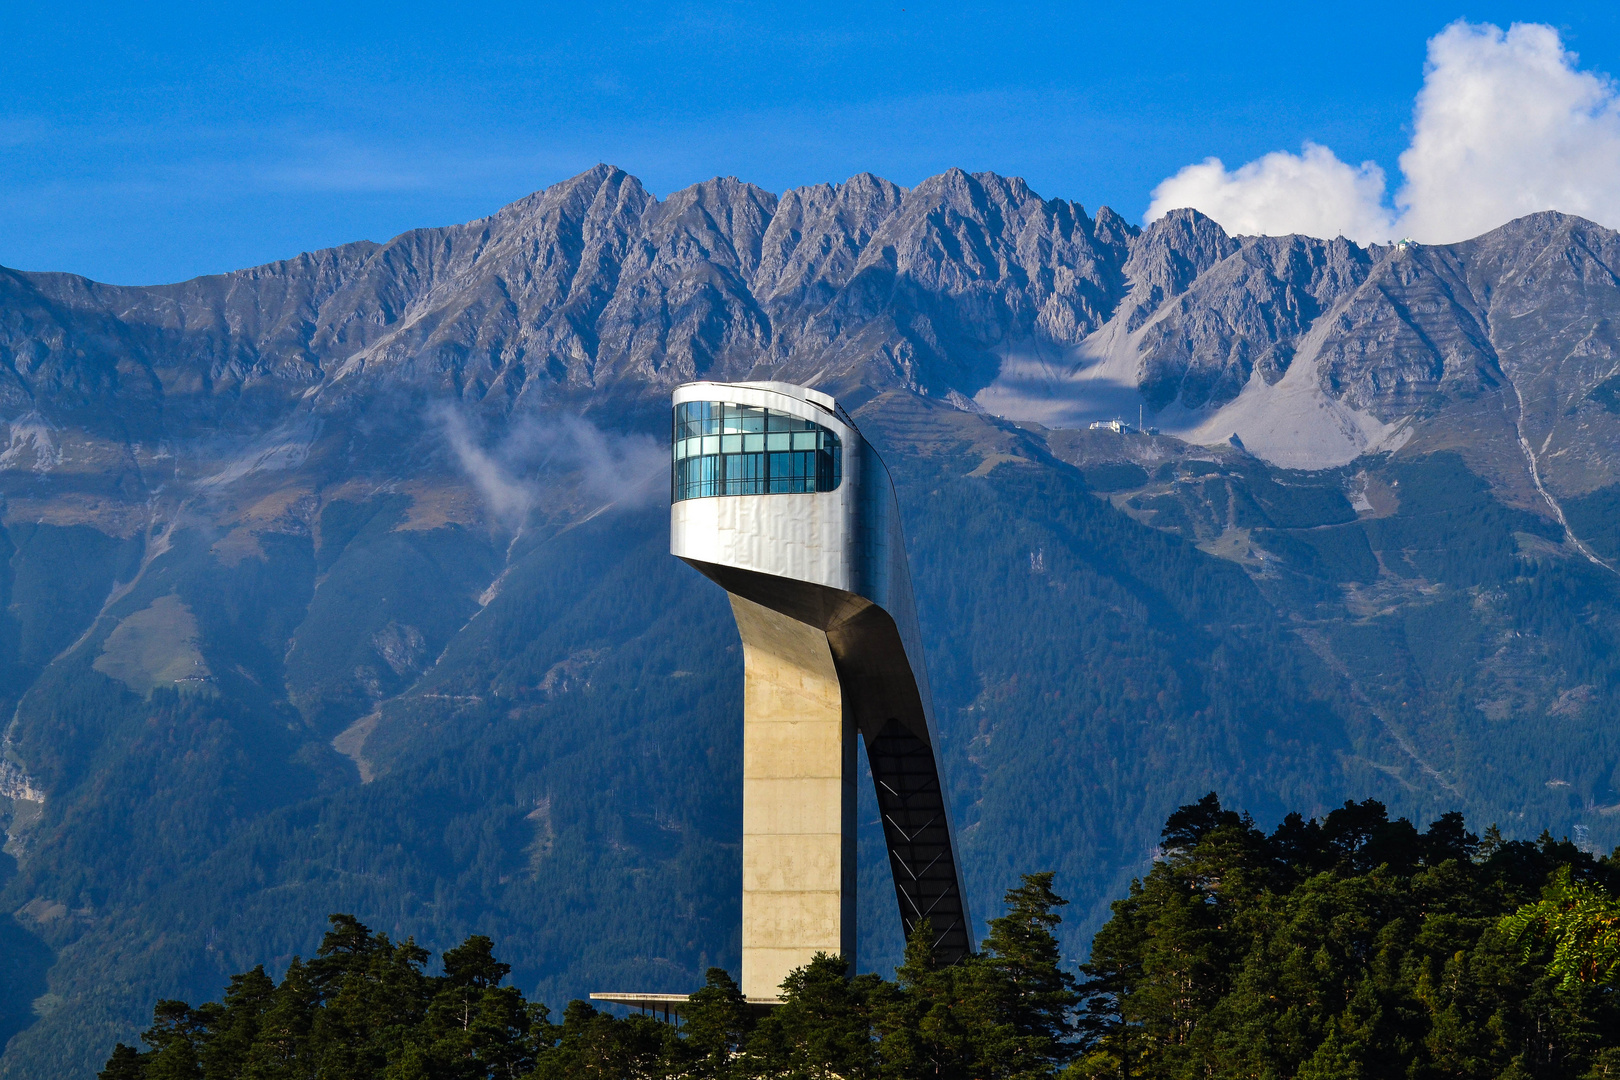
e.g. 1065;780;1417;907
9;397;1620;1080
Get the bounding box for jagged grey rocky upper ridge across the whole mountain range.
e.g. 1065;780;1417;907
0;165;1620;491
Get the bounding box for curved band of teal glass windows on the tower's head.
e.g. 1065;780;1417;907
671;402;844;502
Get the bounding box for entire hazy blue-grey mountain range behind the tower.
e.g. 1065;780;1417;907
0;167;1620;1078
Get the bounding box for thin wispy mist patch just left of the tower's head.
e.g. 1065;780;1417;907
433;405;669;528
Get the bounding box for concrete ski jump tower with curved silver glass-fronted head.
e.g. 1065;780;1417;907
664;382;972;1004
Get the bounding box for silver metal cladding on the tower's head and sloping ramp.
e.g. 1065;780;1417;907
671;382;972;993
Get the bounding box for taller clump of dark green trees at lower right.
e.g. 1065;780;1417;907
1069;793;1620;1080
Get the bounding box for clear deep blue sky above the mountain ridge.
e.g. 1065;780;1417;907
0;0;1620;283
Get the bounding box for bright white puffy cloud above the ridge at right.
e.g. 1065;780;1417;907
1147;23;1620;243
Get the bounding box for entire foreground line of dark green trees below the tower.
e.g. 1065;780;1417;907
100;793;1620;1080
